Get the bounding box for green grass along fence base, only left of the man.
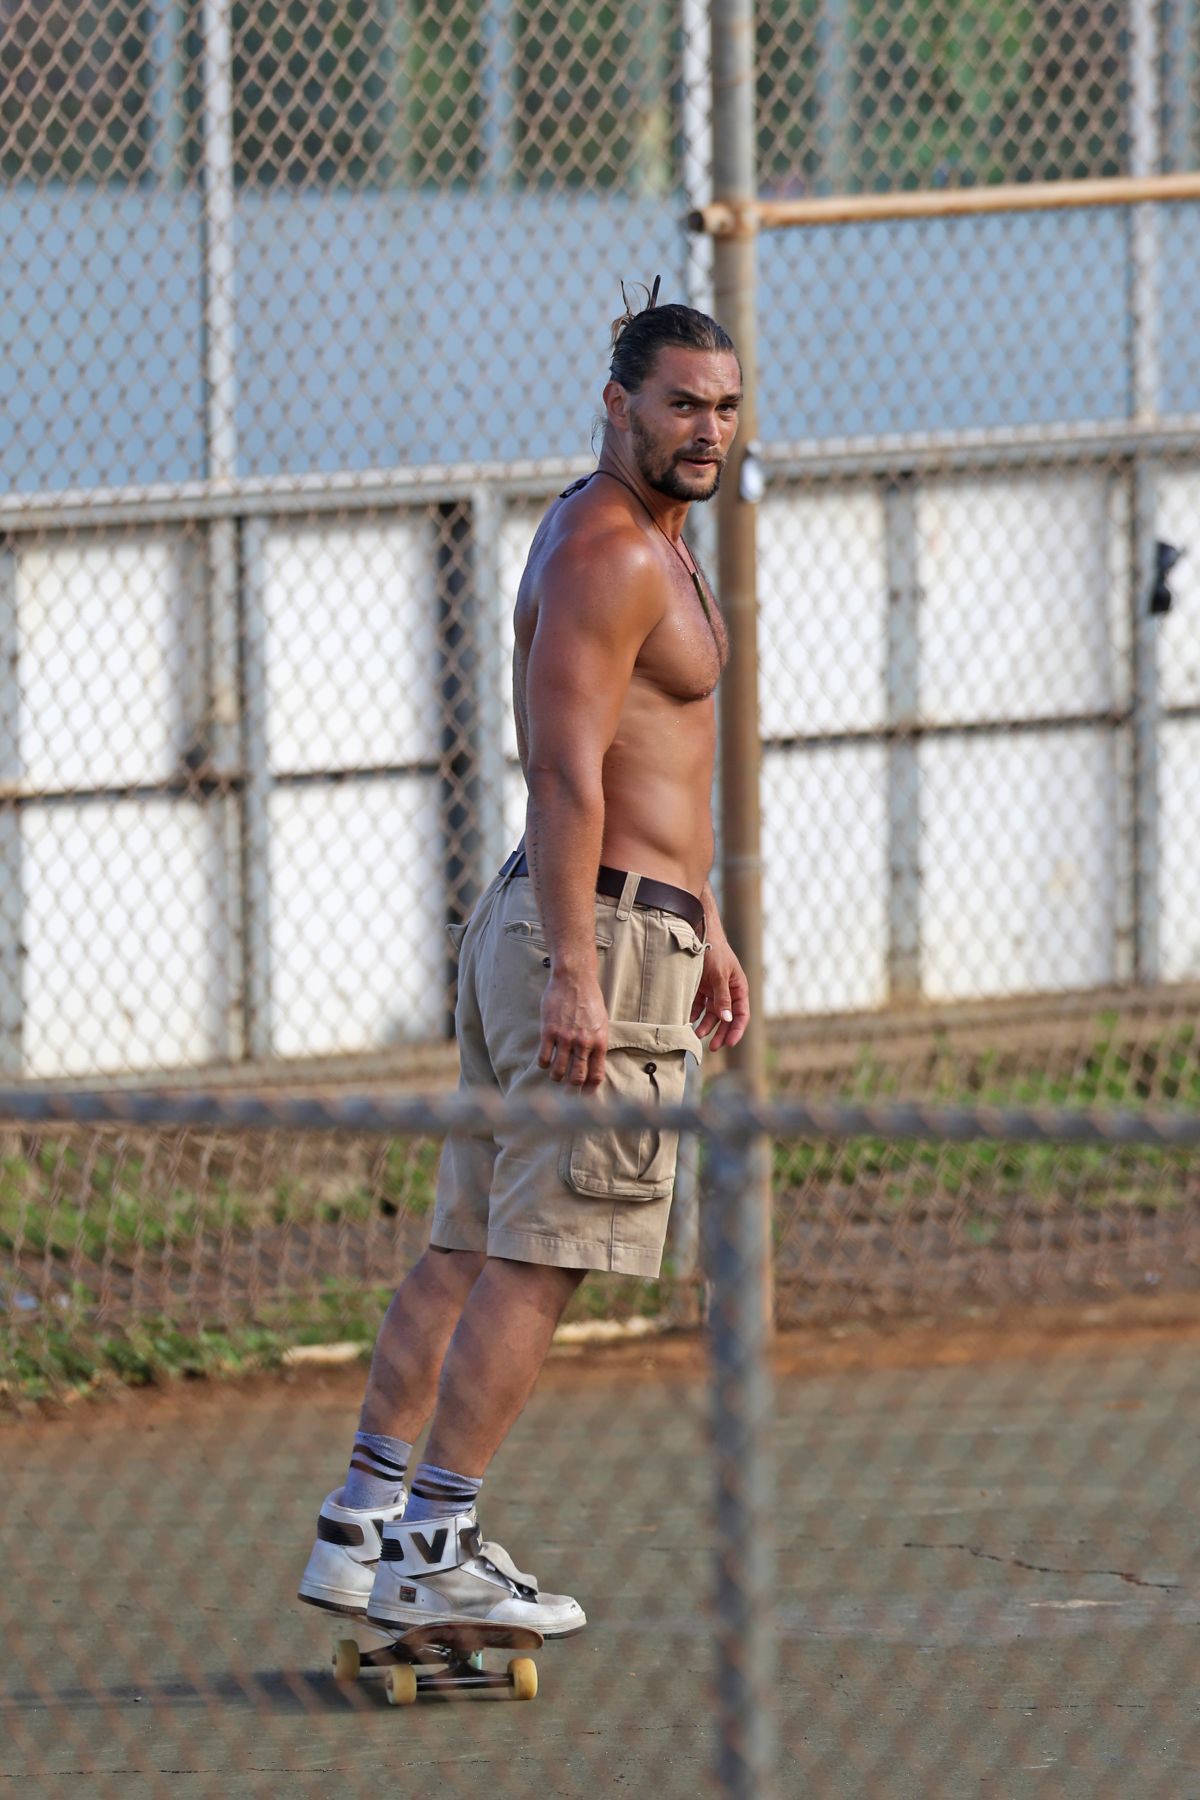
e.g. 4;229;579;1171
0;1132;439;1400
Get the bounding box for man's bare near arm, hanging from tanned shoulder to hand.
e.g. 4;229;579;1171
525;533;662;1091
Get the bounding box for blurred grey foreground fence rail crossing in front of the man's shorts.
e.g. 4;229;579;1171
0;1080;1200;1150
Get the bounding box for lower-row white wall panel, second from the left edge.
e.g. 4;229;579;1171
270;776;446;1057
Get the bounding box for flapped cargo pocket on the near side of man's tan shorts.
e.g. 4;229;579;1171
558;1019;703;1201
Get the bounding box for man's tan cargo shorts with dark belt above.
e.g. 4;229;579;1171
430;860;705;1274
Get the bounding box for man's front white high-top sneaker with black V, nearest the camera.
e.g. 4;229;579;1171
367;1507;587;1638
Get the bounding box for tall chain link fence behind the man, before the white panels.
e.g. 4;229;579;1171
0;0;1200;1346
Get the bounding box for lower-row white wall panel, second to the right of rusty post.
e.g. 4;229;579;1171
919;729;1115;1001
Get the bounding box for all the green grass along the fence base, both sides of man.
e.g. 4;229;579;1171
0;1013;1200;1400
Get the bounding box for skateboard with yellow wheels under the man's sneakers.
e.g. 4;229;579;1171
333;1620;545;1706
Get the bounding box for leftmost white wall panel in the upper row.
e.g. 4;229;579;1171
16;531;203;792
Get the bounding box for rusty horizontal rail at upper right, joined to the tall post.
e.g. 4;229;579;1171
687;171;1200;238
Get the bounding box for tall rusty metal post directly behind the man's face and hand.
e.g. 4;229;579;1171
712;0;772;1319
